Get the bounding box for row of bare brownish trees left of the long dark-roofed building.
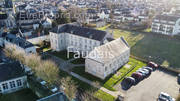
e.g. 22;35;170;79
4;46;59;84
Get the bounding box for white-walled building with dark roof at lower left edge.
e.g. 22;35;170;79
0;62;27;94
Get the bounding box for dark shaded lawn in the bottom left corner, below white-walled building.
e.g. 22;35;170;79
0;89;38;101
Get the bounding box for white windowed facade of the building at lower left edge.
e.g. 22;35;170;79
0;76;27;94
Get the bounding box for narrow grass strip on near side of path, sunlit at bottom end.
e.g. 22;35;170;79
60;71;115;101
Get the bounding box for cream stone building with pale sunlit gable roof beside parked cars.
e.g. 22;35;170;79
85;37;130;79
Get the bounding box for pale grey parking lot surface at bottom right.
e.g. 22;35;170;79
119;70;180;101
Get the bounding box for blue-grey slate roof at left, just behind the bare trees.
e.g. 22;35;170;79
6;34;34;49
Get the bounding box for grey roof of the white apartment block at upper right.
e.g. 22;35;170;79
155;15;180;22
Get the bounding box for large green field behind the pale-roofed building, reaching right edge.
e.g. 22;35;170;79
97;28;180;69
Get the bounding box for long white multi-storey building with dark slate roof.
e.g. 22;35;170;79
50;24;112;55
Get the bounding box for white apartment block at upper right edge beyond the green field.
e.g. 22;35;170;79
151;15;180;35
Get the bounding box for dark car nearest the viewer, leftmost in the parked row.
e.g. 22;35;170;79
121;77;135;90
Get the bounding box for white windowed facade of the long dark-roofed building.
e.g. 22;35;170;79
50;32;101;53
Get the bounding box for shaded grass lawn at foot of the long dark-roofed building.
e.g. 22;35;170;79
48;50;74;60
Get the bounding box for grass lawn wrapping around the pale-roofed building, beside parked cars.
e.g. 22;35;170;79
72;58;146;91
